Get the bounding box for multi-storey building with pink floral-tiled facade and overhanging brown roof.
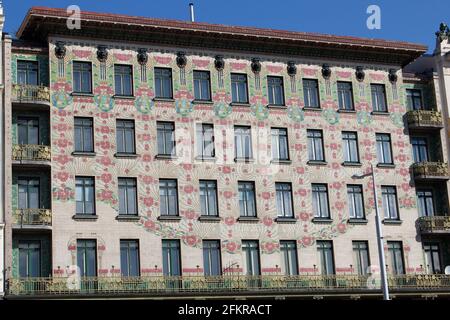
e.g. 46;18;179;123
4;8;450;297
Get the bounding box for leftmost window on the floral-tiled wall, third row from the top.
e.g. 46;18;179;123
75;177;95;215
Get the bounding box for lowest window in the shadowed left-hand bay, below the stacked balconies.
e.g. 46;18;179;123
19;240;41;278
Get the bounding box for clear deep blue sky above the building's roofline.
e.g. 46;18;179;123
3;0;450;52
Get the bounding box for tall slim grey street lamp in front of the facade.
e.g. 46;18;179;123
352;164;390;300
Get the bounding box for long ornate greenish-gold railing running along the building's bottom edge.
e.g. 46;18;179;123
8;274;450;296
